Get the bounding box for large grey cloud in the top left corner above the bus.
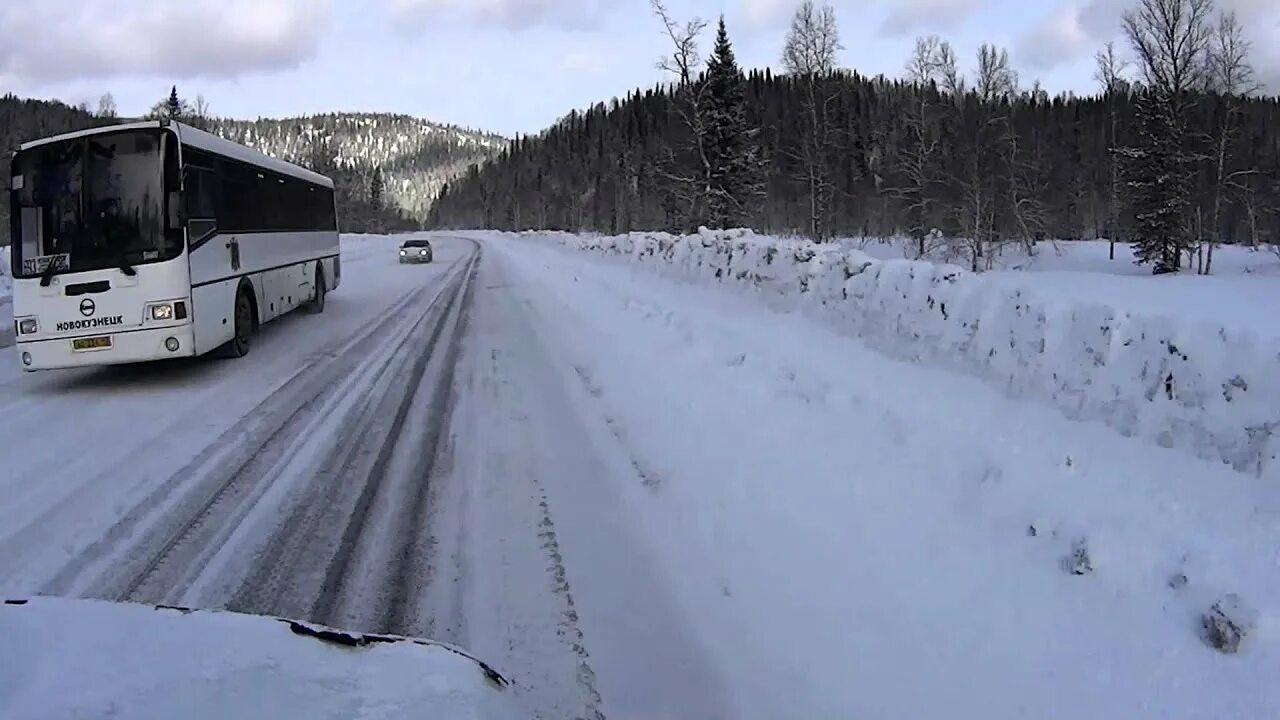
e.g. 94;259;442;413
0;0;332;83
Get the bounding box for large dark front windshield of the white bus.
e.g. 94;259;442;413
12;129;182;279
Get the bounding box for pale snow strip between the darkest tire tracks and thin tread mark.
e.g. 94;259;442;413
419;249;604;720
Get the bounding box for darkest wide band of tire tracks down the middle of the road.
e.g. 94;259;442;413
229;254;479;634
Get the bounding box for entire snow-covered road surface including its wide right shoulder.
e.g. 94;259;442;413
0;236;1280;720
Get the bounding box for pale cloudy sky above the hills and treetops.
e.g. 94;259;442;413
0;0;1280;135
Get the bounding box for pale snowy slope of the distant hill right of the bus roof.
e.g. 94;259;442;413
210;113;507;219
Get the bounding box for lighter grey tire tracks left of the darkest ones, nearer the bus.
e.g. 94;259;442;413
50;245;481;602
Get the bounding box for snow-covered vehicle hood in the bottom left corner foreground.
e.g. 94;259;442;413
0;598;522;720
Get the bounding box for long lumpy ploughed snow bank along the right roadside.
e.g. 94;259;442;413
526;229;1280;479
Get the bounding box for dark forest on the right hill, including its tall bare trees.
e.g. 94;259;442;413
429;0;1280;272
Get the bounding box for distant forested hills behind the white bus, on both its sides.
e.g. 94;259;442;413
0;95;506;238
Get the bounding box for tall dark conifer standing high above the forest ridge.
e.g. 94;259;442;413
699;15;760;228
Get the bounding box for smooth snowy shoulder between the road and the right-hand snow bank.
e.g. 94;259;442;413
486;236;1280;719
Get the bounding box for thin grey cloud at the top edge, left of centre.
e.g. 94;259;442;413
388;0;616;31
